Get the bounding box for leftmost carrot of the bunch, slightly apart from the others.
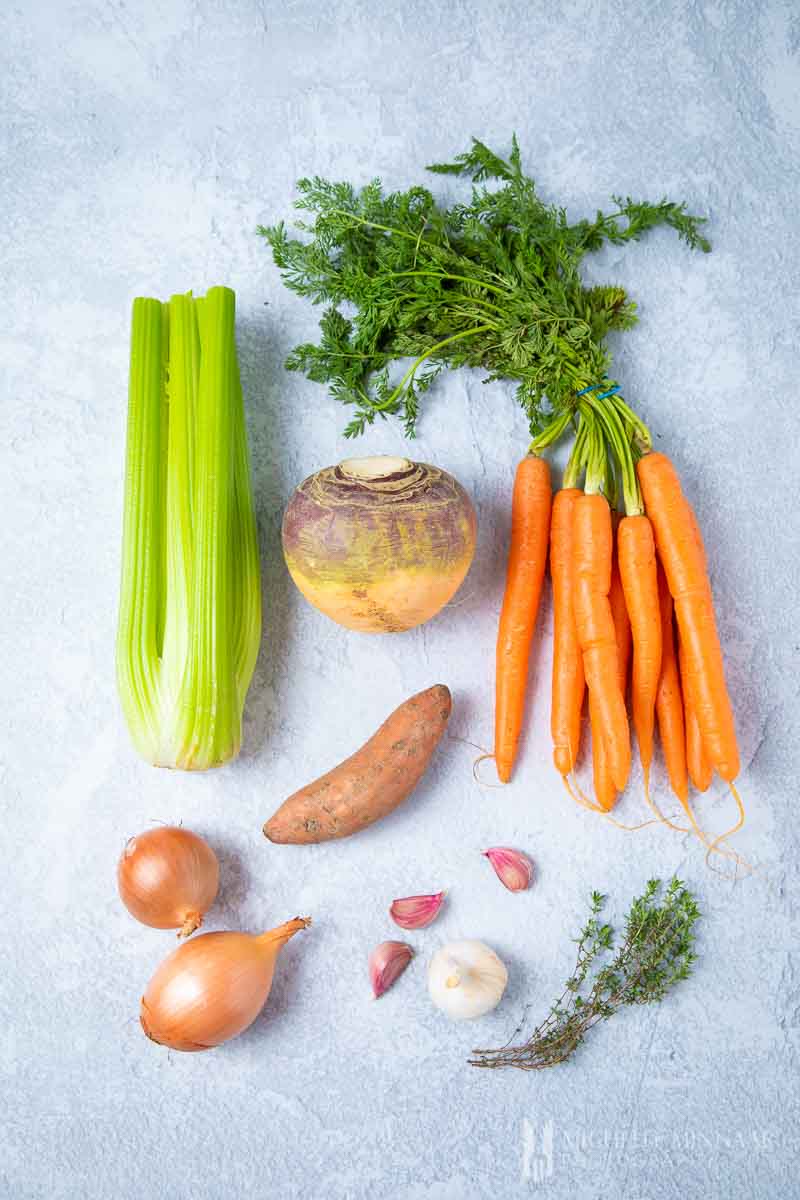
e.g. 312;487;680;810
494;455;551;784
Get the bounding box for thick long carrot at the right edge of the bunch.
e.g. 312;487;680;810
636;452;739;782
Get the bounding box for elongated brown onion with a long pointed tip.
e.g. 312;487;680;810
139;917;311;1050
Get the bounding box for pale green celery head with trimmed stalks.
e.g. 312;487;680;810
116;288;261;770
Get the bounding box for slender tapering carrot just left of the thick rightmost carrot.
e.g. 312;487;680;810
616;516;661;790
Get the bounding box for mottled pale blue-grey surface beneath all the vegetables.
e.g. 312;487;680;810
0;0;800;1200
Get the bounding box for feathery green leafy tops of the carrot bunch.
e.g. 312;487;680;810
259;138;710;438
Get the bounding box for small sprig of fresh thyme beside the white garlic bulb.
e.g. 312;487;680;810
469;877;700;1070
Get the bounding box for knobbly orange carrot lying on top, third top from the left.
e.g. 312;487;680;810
572;493;631;792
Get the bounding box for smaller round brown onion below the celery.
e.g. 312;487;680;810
116;826;219;937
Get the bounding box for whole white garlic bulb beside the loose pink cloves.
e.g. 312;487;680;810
428;941;509;1021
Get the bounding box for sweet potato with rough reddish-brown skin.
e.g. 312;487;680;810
264;684;452;845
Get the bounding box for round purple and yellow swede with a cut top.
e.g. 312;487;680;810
282;458;477;634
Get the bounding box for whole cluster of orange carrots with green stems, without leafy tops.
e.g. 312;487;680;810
494;384;744;853
